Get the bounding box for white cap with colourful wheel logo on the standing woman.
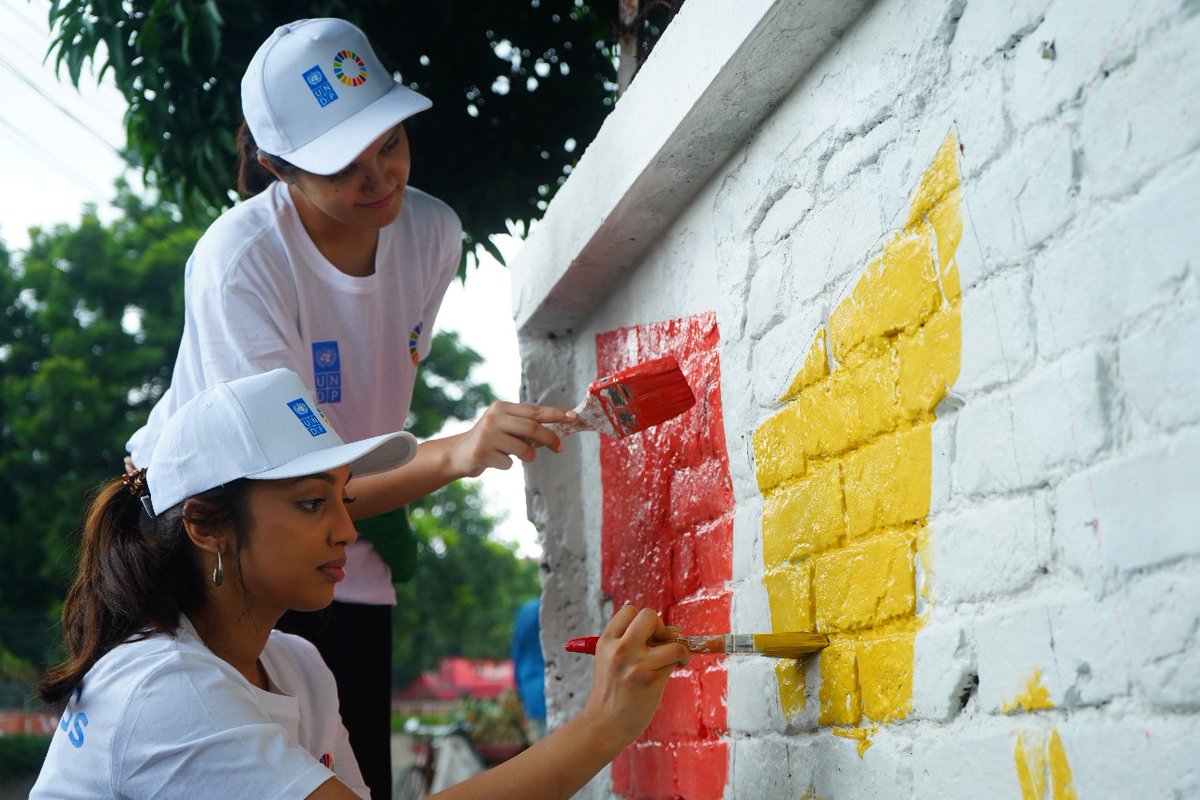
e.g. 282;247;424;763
241;18;433;175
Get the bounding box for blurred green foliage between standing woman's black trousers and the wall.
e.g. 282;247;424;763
392;481;541;687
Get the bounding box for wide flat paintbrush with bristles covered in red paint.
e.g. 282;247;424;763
546;355;696;439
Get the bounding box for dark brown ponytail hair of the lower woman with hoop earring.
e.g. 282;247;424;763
37;479;250;703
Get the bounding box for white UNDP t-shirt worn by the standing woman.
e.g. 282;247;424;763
126;181;462;604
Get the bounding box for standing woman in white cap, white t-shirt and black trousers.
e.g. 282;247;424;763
128;19;571;793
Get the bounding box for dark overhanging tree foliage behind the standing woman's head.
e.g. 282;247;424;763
49;0;618;260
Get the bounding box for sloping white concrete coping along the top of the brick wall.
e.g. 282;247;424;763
511;0;874;335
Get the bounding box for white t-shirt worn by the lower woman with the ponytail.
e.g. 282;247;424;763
29;618;370;800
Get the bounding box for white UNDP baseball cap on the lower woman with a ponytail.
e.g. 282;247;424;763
142;369;416;516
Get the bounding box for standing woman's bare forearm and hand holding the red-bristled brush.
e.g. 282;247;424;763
347;402;576;519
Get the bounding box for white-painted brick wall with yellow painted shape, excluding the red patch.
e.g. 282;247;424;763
514;0;1200;799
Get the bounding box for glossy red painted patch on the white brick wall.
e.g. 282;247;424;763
596;312;733;800
